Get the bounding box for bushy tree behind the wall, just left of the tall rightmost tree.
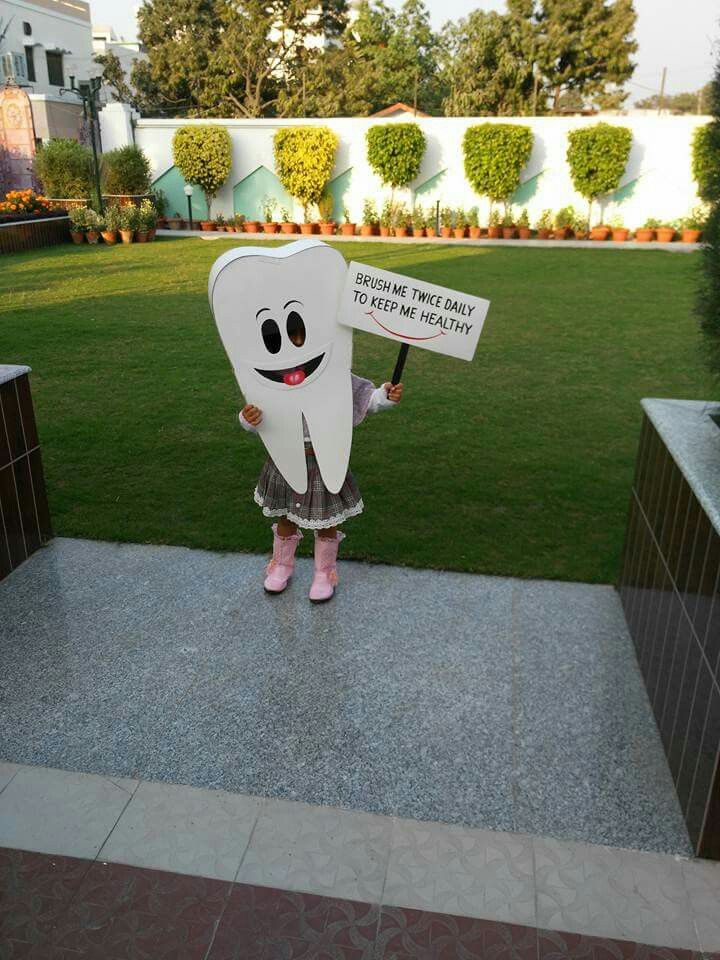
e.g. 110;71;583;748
443;10;544;117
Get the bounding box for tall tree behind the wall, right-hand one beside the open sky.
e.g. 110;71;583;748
508;0;637;113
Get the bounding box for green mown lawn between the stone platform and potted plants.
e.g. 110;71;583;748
0;238;713;582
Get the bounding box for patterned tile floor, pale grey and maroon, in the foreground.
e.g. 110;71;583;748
0;764;720;960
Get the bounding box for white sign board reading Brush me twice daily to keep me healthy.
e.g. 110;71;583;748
338;261;490;360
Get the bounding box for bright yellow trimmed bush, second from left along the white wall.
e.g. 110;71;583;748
273;127;338;223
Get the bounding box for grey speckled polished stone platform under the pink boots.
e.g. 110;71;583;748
0;539;689;854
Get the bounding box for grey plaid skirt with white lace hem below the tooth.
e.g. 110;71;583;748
255;448;363;530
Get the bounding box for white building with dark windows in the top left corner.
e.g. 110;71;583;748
0;0;99;140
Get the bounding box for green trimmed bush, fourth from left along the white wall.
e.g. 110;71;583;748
463;123;533;214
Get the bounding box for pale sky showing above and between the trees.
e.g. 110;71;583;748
90;0;720;102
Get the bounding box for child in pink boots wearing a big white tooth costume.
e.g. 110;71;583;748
208;239;402;603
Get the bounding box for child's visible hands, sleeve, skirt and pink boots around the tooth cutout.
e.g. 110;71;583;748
240;373;403;603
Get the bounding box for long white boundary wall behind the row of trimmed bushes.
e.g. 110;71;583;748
100;108;710;227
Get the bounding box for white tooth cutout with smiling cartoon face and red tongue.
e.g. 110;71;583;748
208;240;352;493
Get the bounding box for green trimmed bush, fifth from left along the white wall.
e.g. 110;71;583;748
566;123;632;225
